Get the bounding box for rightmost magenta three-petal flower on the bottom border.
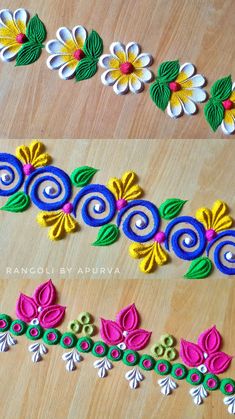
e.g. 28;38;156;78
180;326;232;374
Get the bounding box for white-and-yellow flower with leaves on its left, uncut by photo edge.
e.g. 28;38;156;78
167;63;207;118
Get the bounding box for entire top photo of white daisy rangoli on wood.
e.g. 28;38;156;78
0;0;235;139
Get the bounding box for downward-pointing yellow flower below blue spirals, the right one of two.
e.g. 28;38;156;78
129;232;168;273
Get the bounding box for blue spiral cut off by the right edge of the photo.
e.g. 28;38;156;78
206;230;235;275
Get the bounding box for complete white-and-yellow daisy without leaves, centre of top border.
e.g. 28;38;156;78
99;42;153;95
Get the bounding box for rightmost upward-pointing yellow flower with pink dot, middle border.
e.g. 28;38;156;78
196;200;233;241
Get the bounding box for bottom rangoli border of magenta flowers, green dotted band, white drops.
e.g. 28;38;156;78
0;280;235;414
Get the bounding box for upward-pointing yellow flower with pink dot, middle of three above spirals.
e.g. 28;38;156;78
107;172;143;210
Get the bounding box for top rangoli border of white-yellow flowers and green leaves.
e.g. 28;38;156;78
0;8;235;135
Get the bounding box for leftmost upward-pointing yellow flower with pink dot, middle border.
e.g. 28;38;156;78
16;140;51;175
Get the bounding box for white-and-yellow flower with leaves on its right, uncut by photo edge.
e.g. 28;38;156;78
46;26;87;80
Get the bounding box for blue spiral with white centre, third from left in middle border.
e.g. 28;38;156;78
73;184;116;227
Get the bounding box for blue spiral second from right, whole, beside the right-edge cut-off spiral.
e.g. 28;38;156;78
165;217;206;260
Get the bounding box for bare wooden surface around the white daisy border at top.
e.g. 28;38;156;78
0;0;235;139
